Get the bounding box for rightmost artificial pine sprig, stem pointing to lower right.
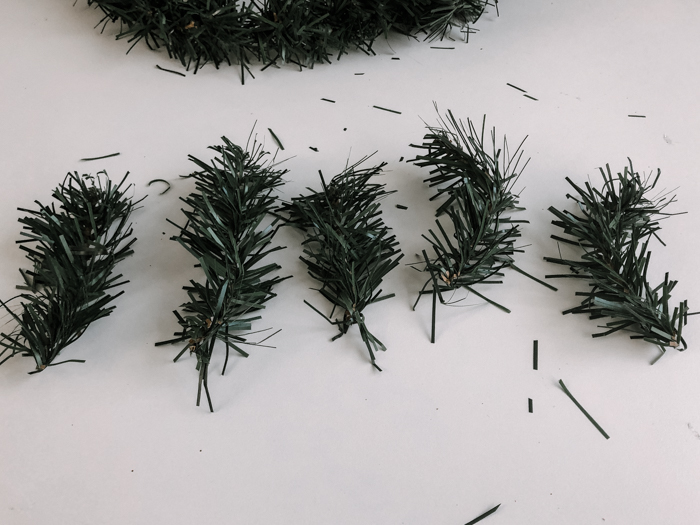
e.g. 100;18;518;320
545;161;688;352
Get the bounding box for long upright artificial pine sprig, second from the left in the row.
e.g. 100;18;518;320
156;137;286;412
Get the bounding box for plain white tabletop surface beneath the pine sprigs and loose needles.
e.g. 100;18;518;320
0;0;700;525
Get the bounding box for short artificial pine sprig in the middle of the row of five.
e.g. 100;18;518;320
281;157;403;371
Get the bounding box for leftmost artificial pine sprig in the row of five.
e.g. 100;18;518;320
0;172;138;373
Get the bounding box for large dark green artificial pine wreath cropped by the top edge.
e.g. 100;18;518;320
88;0;488;81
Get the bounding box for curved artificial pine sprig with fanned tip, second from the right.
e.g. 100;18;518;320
412;110;555;343
